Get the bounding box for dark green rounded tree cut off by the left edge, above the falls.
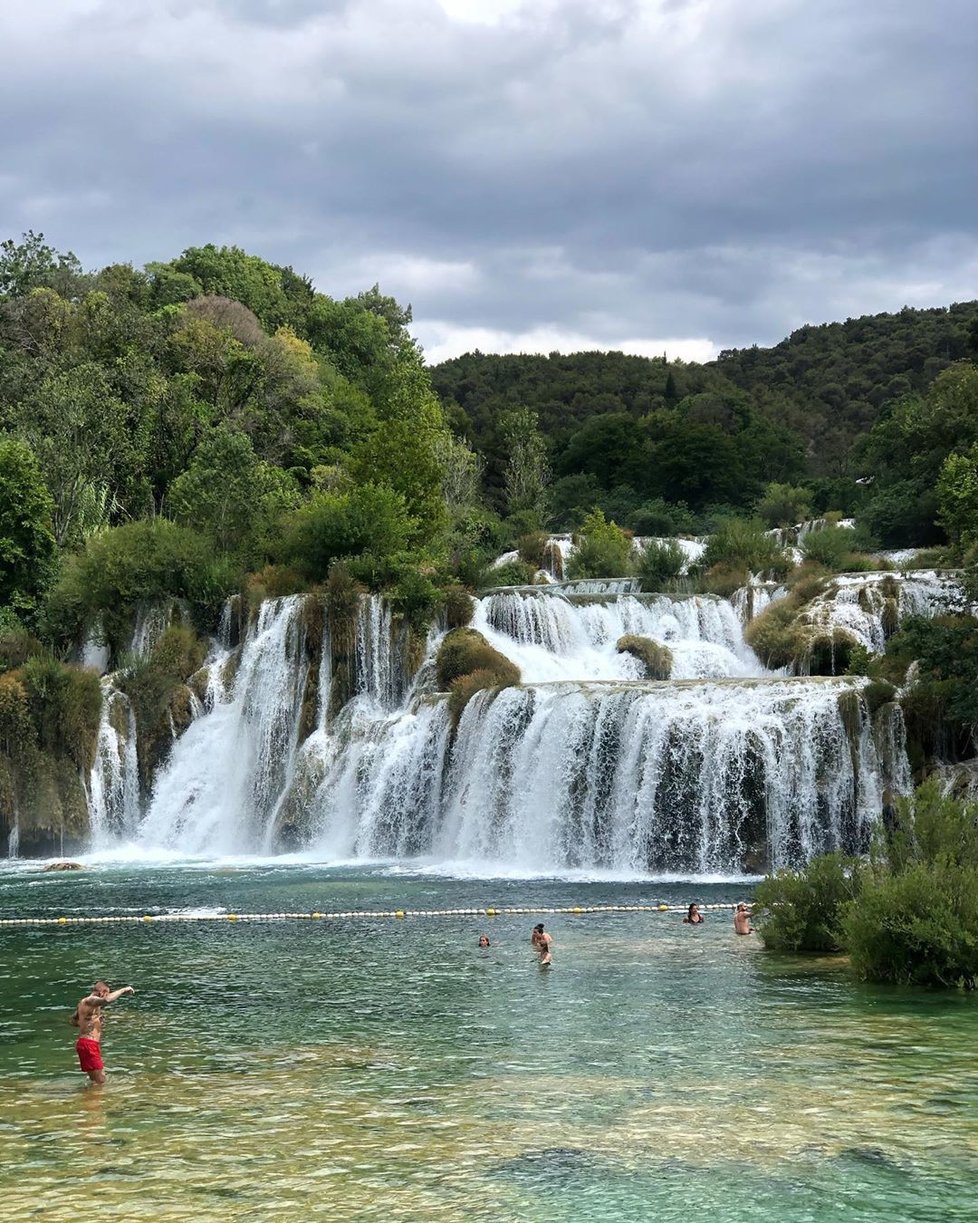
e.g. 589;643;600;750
0;438;55;613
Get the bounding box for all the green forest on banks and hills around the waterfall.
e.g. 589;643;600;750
0;232;978;846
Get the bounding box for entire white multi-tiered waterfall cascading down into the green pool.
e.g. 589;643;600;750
81;575;916;876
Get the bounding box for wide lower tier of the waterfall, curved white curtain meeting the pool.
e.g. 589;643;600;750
312;680;881;873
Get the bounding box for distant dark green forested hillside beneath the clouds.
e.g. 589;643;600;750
432;302;978;543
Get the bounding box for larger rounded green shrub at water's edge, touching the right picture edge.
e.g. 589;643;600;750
841;862;978;989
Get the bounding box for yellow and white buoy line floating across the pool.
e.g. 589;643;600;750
0;904;736;927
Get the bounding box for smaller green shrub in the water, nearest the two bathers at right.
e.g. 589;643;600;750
753;854;864;951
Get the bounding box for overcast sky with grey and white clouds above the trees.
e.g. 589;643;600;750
0;0;978;361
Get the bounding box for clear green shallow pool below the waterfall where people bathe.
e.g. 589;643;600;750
0;863;978;1223
